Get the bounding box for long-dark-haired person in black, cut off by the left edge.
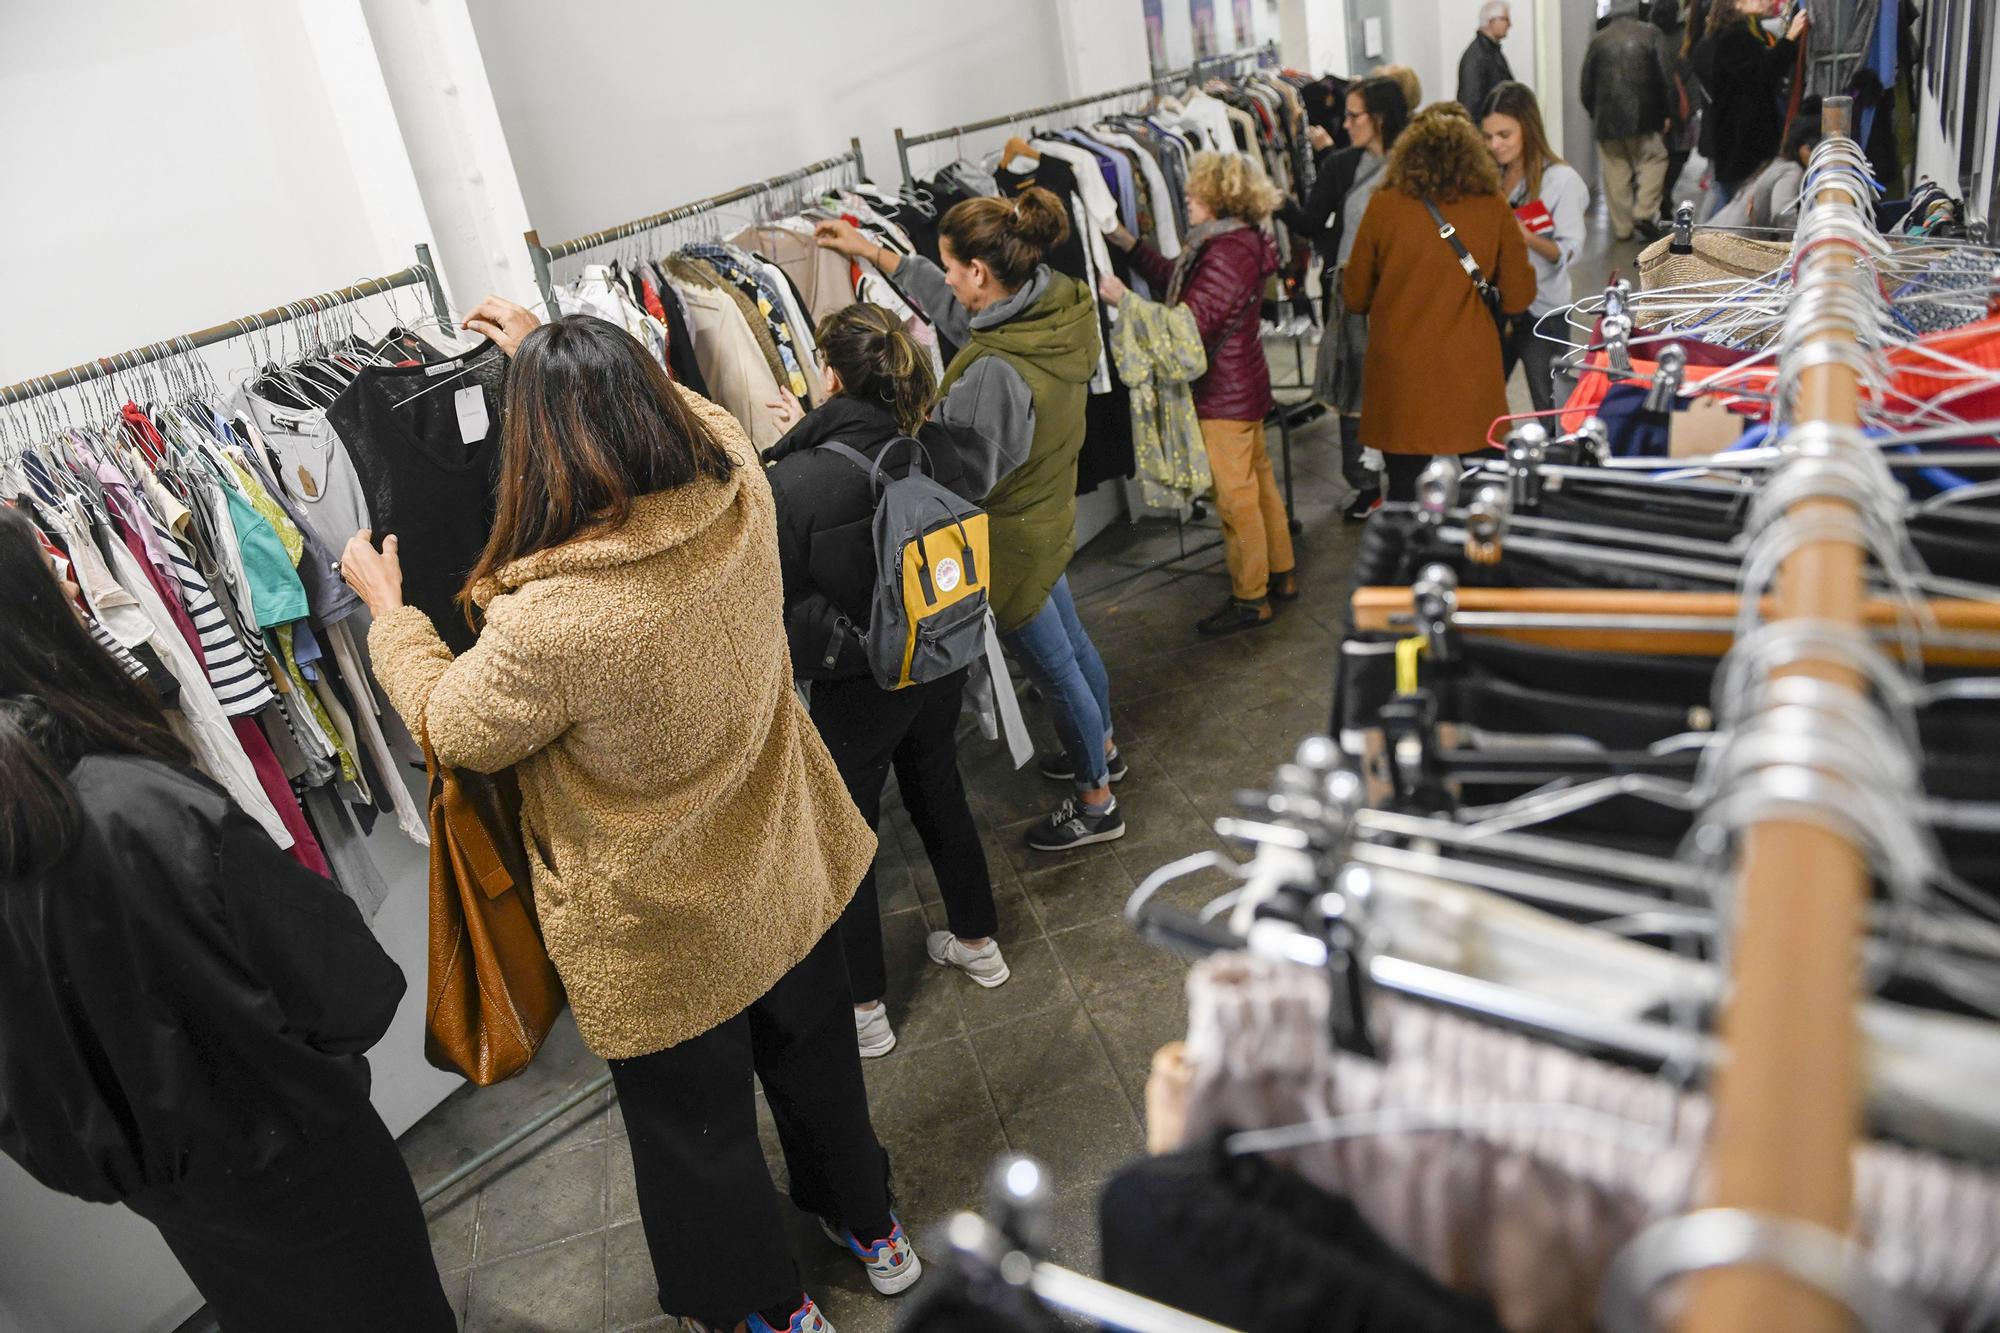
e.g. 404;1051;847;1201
0;504;458;1333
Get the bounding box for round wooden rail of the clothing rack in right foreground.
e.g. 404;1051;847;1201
1680;96;1872;1333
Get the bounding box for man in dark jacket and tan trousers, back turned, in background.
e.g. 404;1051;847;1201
1582;0;1674;240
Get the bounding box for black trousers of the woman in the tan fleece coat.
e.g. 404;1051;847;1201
610;931;892;1329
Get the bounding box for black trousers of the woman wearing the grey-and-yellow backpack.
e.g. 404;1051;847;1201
812;671;1000;1003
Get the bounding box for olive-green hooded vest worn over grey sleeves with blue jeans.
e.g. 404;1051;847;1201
940;272;1102;632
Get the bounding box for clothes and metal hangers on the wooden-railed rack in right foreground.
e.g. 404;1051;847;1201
912;124;2000;1333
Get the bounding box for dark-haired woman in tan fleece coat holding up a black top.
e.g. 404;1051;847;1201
342;300;922;1331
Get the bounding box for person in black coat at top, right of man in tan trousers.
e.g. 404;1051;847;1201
1694;0;1808;212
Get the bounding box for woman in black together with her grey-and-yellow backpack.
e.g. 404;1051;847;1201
764;304;1008;1057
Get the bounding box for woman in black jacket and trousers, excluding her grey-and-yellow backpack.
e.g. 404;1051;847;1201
764;304;1008;1057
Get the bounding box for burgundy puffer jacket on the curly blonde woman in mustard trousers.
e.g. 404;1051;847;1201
1132;226;1278;420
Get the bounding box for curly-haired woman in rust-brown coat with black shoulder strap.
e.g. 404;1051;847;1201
1342;104;1534;500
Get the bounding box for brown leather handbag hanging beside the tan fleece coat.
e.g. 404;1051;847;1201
424;745;564;1087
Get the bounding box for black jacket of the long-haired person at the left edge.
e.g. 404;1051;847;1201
0;755;404;1203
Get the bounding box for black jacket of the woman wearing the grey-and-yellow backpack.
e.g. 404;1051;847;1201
764;394;992;681
